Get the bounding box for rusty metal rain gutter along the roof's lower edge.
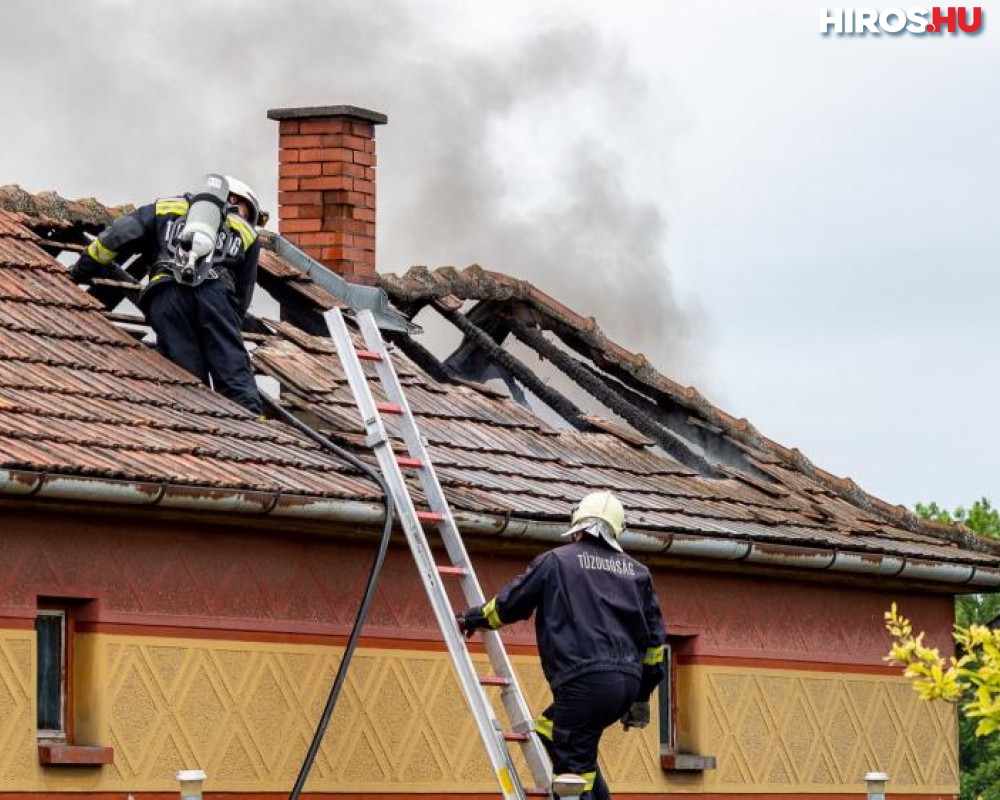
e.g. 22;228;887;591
0;469;1000;590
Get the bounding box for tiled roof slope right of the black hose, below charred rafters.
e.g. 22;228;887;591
254;323;996;564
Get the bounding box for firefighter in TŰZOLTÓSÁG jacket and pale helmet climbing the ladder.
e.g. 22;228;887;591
458;492;665;800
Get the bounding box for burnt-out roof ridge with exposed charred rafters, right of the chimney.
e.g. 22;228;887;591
380;265;992;547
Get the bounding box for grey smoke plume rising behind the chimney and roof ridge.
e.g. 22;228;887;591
0;0;690;371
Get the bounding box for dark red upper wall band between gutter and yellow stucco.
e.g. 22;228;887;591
0;511;952;664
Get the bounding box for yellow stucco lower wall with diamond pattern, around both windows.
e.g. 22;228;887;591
0;631;957;793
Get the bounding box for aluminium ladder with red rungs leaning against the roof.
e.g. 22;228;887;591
323;308;552;800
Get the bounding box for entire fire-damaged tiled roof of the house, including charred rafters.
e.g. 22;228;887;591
0;189;1000;567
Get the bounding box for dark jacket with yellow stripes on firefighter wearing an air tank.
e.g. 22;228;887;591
81;196;260;317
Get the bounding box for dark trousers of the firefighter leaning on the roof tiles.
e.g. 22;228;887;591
143;280;261;415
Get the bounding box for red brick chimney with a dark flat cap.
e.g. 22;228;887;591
267;106;388;285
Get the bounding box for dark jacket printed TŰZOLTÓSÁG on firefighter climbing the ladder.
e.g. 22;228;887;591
480;537;665;701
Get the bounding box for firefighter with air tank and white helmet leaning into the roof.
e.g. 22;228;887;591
70;175;267;415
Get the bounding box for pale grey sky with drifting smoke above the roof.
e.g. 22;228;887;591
0;0;1000;505
